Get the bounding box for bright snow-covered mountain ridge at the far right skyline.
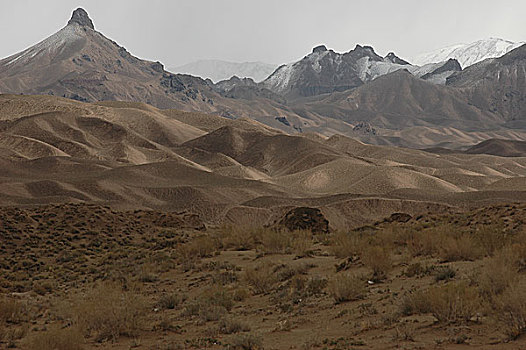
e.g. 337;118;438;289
412;38;524;68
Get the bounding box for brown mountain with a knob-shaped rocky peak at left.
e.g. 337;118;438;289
0;8;221;110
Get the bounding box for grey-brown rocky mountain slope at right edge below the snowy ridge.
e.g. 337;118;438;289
447;44;526;128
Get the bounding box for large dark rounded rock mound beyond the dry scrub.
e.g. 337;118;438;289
278;207;329;233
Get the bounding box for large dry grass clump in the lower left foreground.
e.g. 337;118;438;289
66;283;148;342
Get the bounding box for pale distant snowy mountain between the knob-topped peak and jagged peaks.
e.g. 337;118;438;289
168;60;276;83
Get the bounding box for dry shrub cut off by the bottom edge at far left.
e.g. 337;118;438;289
27;328;84;350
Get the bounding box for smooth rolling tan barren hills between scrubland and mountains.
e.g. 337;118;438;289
0;95;526;227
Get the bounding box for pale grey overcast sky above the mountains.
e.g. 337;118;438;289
0;0;526;67
